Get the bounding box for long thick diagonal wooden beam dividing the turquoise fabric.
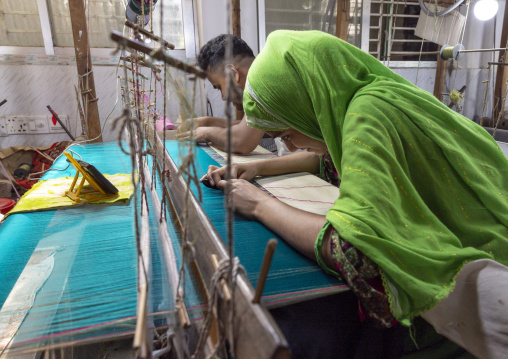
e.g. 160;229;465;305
146;126;290;358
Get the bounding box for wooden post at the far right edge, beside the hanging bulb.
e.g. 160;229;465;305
491;3;508;130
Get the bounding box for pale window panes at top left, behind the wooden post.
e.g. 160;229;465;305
0;0;189;52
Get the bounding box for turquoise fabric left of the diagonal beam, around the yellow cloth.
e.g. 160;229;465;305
0;143;199;349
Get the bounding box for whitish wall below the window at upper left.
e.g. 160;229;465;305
0;60;190;149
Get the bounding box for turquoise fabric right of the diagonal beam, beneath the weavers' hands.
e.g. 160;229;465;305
166;141;347;307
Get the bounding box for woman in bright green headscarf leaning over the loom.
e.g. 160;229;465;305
201;31;508;358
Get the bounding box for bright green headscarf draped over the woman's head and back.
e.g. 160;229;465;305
244;31;508;325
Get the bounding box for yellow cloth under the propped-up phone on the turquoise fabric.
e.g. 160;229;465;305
6;173;134;217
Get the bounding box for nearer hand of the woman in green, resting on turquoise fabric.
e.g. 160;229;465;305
217;179;274;219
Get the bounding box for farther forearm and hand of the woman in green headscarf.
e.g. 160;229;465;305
201;152;319;186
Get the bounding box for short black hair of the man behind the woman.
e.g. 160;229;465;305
198;34;254;71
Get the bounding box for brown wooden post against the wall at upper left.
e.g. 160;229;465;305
69;0;102;142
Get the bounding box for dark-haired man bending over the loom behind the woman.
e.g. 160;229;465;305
176;35;275;153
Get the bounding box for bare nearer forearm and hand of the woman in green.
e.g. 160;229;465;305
217;180;329;260
